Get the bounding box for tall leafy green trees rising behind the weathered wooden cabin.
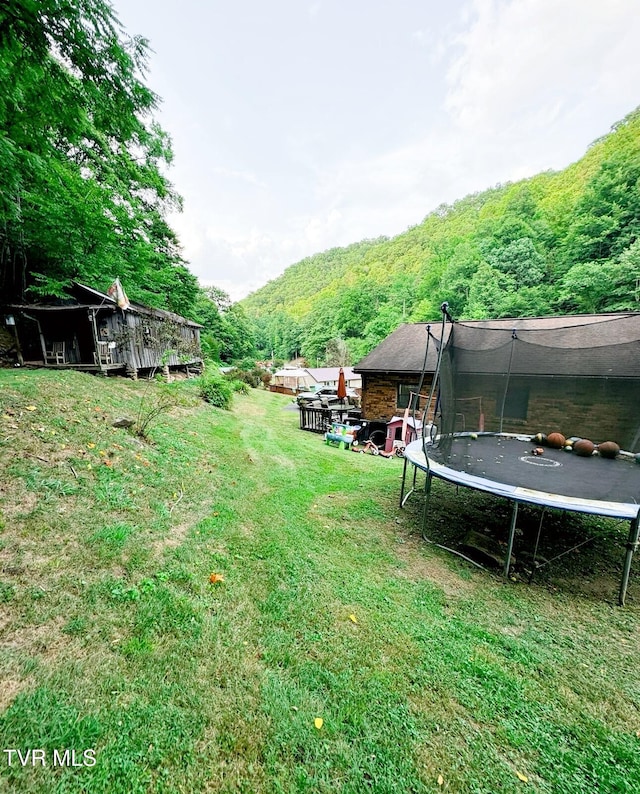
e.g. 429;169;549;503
0;0;196;312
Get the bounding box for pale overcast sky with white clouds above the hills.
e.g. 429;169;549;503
112;0;640;301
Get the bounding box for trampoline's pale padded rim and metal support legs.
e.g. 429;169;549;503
400;433;640;606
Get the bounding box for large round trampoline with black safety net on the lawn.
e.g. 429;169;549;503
400;306;640;605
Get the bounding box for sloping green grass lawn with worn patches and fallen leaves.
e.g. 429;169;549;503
0;370;640;794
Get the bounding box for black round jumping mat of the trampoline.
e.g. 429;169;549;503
429;434;640;504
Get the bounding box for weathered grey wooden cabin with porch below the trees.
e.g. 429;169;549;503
0;283;202;377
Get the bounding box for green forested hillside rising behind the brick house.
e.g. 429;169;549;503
240;109;640;362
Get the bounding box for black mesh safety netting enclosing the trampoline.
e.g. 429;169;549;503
433;315;640;498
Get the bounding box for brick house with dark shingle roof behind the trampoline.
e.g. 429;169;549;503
354;313;640;451
